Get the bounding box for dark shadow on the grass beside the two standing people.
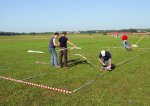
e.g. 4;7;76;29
67;59;89;67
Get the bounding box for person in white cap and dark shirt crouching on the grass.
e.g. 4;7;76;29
99;50;111;70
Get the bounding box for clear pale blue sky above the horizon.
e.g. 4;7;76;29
0;0;150;32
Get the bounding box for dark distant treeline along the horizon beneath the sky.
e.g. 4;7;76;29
0;29;150;36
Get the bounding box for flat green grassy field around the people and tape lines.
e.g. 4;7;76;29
0;34;150;106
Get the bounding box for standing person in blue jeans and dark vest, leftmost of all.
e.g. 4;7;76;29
49;32;60;67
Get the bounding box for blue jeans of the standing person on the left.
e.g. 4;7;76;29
49;48;58;66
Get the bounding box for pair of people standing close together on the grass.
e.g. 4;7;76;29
49;32;76;68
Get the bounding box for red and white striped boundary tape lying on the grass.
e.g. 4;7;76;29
0;76;72;93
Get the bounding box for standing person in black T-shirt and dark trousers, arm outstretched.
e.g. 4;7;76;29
58;32;76;68
